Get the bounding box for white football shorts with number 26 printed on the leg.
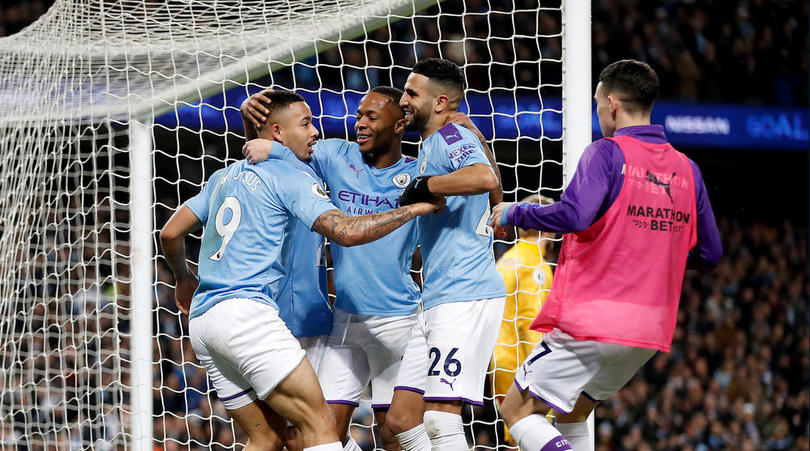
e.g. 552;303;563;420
397;298;506;405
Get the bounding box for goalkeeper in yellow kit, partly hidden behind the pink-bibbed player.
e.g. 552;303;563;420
490;194;555;443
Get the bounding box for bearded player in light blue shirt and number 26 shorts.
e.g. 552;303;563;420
392;59;506;451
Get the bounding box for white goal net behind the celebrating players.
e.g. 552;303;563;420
0;0;590;450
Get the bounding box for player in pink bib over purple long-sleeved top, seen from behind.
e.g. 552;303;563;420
492;60;722;450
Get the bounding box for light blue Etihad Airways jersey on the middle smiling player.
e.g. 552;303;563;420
311;139;420;316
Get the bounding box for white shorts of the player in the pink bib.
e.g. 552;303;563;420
515;329;656;413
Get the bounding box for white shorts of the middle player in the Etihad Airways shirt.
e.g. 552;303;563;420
318;309;417;409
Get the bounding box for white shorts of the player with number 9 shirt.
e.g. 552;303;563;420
189;298;304;410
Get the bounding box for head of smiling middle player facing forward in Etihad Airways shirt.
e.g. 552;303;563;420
354;92;404;153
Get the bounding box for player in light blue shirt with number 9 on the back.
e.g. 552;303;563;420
161;90;442;451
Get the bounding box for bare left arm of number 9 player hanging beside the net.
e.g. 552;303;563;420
160;205;202;315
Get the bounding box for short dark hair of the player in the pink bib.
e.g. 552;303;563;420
599;60;659;111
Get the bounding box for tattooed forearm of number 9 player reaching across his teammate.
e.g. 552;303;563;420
312;198;444;247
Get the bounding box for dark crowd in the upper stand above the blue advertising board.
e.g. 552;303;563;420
0;0;810;106
